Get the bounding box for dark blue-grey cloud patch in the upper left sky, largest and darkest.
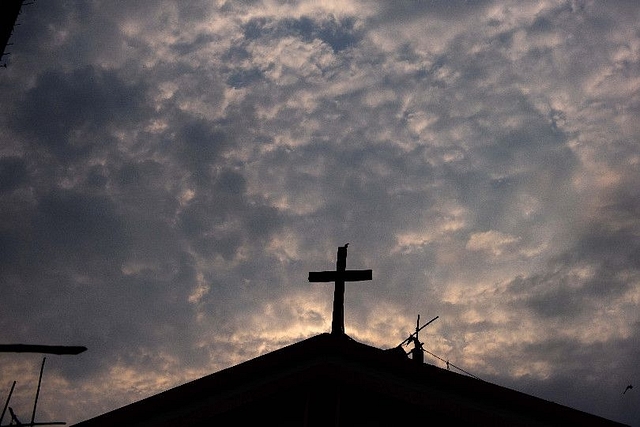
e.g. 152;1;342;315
14;67;144;161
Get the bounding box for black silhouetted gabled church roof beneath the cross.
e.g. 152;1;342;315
76;334;622;427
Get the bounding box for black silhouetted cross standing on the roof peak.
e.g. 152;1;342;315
309;243;373;335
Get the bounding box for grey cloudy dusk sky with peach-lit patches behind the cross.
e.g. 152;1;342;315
0;0;640;425
